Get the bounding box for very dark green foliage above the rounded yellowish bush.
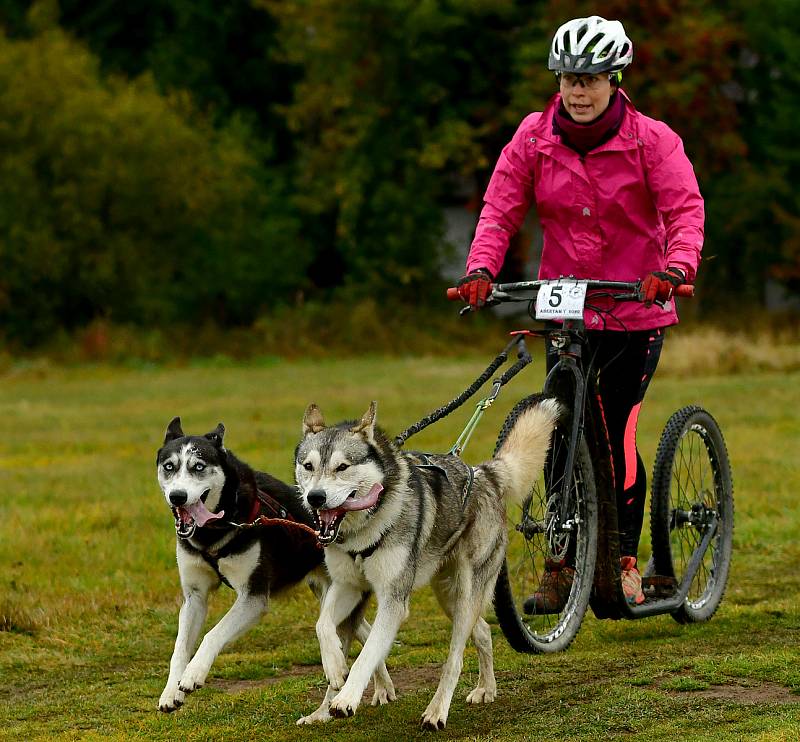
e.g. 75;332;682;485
55;0;294;141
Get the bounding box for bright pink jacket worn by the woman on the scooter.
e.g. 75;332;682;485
467;91;705;330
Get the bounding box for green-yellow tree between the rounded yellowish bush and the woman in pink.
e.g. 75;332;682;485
265;0;516;296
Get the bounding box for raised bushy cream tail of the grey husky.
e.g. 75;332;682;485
492;399;561;503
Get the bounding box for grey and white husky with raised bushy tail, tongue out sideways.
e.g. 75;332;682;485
295;400;559;729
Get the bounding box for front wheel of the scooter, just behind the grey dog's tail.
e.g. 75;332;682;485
494;395;597;653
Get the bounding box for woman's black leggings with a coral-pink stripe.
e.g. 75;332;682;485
547;328;664;556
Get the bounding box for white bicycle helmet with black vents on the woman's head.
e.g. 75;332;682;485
547;15;633;74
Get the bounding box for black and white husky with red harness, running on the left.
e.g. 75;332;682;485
156;417;394;718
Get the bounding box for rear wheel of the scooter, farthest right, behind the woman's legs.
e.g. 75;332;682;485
650;405;733;623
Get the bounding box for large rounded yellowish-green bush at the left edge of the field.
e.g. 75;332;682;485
0;25;305;342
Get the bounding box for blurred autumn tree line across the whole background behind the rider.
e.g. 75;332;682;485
0;0;800;342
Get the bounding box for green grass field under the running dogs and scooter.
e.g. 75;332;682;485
0;357;800;742
